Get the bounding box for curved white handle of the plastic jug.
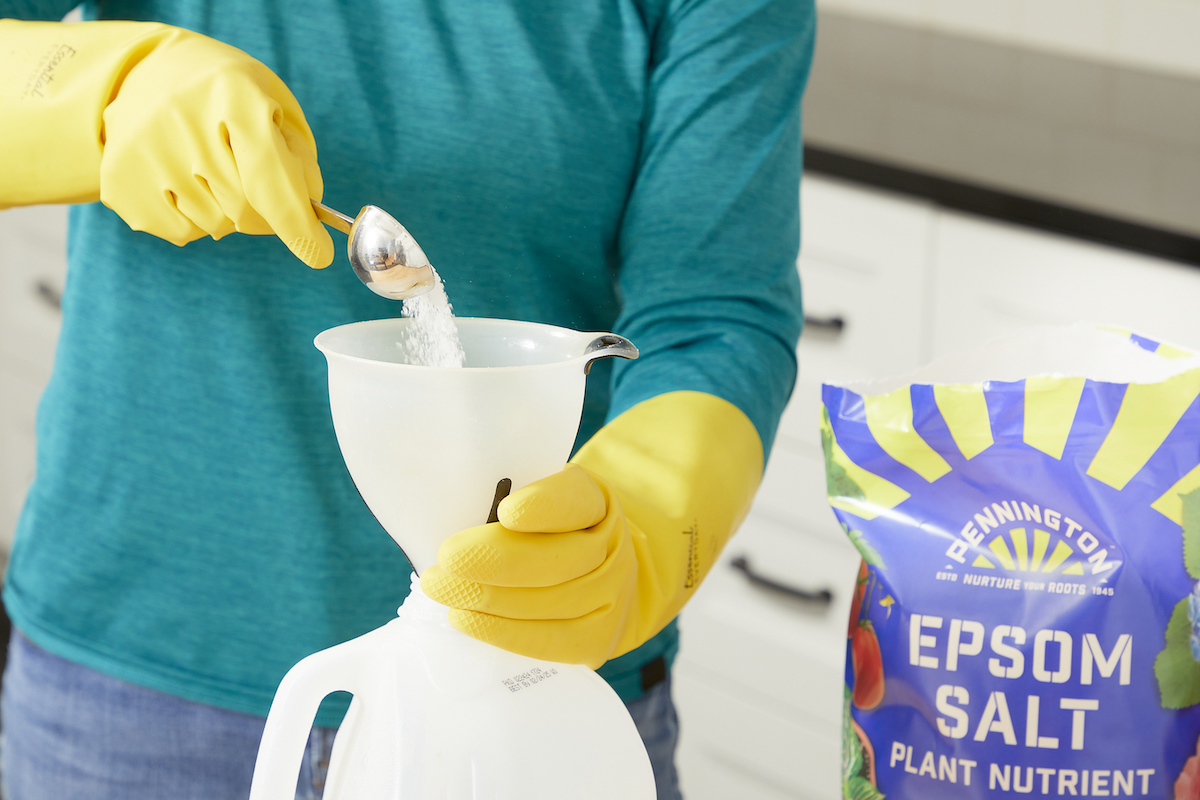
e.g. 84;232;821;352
250;639;362;800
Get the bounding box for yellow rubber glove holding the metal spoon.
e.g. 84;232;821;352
0;19;334;267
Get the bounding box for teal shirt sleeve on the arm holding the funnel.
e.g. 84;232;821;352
608;0;815;458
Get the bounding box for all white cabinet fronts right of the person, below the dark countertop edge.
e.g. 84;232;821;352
674;175;1200;800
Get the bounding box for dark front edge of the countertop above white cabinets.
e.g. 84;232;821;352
804;145;1200;266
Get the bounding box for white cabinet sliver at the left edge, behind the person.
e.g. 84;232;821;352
0;206;67;564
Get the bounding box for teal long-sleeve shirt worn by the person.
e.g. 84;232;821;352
0;0;814;724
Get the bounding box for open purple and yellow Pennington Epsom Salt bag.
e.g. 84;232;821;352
822;326;1200;800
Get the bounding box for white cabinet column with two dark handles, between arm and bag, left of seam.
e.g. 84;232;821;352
674;178;936;800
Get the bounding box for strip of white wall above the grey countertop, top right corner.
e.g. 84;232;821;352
820;0;1200;77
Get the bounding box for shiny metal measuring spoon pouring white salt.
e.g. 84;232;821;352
312;200;433;300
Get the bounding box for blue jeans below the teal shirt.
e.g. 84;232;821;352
0;631;680;800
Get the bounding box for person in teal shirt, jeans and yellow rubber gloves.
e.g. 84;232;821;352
0;0;814;800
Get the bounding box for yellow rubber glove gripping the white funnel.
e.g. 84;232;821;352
421;392;762;668
